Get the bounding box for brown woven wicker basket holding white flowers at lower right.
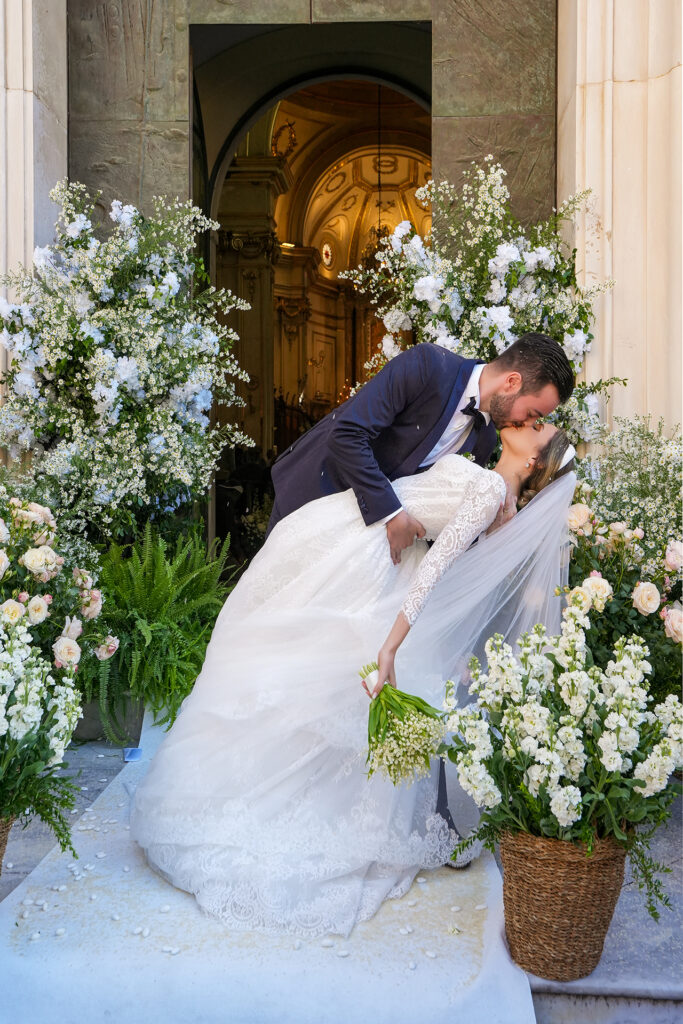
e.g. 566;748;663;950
501;833;626;981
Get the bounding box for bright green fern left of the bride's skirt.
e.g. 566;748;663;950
80;523;235;742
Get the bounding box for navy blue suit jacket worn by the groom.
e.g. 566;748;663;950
268;342;496;531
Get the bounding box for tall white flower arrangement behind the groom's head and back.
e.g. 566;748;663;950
340;156;613;441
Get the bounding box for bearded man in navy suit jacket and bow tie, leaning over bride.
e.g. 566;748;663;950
268;334;574;564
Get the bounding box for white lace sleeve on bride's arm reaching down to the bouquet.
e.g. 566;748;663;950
400;473;505;626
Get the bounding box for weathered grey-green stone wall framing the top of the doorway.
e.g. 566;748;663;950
69;0;555;224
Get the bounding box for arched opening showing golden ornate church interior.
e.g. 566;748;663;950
214;79;431;452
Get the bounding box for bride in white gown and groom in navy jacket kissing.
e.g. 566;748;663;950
131;334;574;936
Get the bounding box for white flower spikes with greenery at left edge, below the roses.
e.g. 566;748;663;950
0;614;81;855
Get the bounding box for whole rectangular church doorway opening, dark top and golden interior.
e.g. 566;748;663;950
190;26;431;553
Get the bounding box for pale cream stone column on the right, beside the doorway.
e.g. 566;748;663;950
557;0;682;425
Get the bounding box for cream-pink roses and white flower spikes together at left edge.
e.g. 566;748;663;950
0;486;119;862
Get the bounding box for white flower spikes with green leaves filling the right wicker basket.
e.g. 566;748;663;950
446;593;683;918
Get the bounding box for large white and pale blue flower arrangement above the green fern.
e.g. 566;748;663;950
0;181;253;536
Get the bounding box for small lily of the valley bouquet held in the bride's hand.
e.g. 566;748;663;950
360;662;444;785
